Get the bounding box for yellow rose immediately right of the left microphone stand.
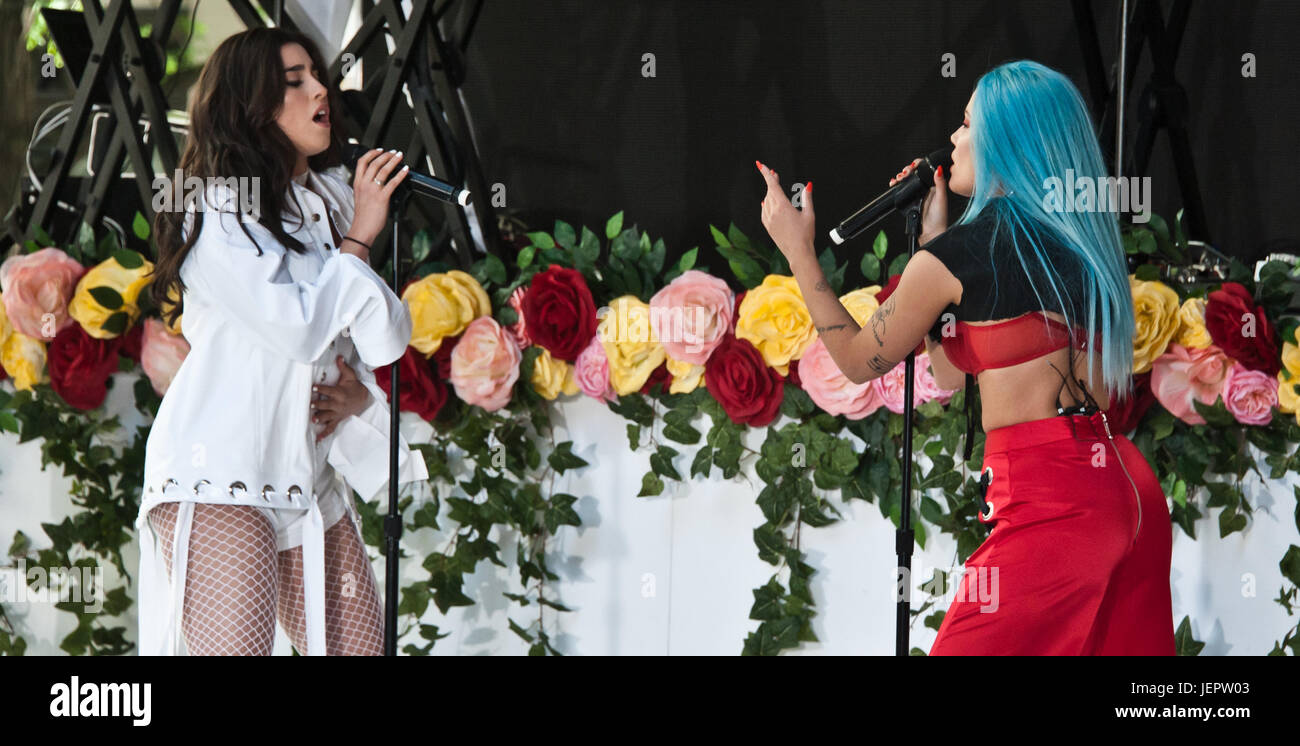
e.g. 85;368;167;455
402;269;491;357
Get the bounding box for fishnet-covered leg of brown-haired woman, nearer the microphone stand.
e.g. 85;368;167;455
280;513;384;655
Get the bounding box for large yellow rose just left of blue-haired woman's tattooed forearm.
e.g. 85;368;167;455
736;274;816;376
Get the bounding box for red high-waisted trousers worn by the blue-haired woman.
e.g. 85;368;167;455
930;412;1174;655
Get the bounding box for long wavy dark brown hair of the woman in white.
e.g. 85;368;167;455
151;29;341;324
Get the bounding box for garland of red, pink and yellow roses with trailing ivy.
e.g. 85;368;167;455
0;213;1300;654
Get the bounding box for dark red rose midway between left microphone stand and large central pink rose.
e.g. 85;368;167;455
523;266;597;363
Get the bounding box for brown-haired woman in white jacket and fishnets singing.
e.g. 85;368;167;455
137;29;428;655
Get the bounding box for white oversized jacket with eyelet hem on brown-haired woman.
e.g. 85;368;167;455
137;168;429;655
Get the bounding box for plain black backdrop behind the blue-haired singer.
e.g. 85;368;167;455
465;0;1300;277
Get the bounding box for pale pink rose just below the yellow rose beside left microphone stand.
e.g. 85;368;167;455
451;316;523;412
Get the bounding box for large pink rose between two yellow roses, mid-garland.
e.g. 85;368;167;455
650;269;736;365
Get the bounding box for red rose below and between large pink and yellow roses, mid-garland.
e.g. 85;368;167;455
705;333;785;428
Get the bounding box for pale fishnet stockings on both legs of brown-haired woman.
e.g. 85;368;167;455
150;503;384;655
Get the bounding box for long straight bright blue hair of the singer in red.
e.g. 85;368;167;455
957;60;1135;400
